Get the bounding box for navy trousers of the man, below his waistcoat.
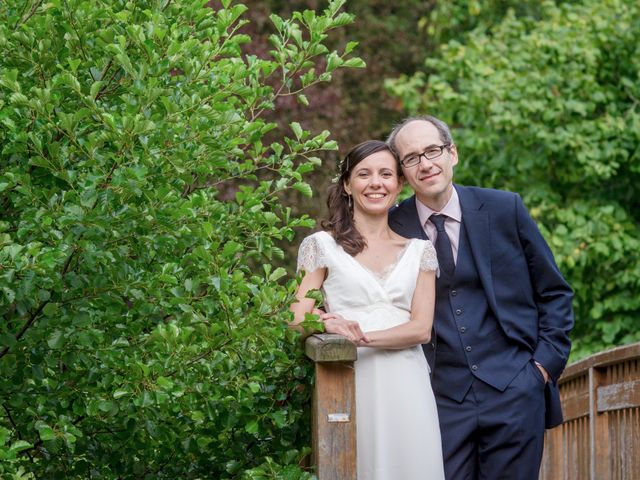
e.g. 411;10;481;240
435;361;545;480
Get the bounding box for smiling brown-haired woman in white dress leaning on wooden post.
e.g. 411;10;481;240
291;140;444;480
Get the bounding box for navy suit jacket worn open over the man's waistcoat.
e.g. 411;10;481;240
389;185;573;427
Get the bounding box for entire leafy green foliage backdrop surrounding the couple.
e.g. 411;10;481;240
0;0;640;479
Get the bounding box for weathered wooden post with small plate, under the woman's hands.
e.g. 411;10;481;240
305;334;357;480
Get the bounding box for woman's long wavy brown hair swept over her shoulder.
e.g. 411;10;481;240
322;140;402;255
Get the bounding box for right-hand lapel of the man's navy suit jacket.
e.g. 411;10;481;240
455;185;500;318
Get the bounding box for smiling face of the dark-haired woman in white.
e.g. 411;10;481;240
344;150;402;215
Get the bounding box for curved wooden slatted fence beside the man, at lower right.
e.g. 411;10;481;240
540;343;640;480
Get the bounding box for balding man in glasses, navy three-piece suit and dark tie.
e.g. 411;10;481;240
388;116;573;480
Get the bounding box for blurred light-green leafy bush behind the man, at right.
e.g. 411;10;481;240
389;0;640;358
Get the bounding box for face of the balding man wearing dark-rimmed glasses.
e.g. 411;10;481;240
395;120;458;211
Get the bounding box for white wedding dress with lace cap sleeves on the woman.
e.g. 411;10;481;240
298;232;444;480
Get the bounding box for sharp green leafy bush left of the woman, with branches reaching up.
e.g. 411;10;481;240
0;0;362;479
